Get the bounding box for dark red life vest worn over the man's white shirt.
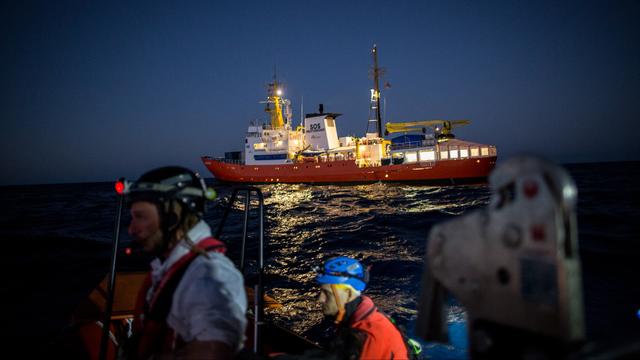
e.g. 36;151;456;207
129;237;226;359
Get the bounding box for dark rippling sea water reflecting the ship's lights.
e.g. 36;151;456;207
0;162;640;359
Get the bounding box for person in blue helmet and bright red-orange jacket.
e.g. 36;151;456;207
316;256;409;359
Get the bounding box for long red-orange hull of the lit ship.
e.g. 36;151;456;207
202;156;496;184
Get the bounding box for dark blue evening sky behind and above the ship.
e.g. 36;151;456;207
0;0;640;184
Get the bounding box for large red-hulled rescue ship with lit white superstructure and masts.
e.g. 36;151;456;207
201;45;497;184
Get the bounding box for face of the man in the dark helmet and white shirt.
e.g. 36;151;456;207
129;201;163;252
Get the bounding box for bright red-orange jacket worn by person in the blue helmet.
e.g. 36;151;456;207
349;295;409;359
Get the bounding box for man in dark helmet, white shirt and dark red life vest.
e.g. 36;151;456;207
125;167;247;359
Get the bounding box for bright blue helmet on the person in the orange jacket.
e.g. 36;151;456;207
316;256;369;291
